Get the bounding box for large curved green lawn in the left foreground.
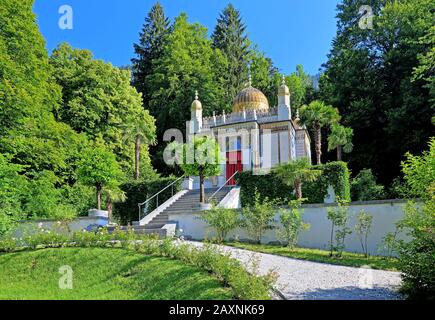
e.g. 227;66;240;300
0;248;232;300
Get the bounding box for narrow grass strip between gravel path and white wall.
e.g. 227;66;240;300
225;242;398;271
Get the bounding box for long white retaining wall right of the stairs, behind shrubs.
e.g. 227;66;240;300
169;200;407;255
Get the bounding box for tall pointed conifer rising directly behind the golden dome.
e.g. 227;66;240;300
212;4;250;106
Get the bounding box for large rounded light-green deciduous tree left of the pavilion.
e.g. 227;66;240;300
50;44;156;172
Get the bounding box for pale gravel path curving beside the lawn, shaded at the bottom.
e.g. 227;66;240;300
189;242;402;300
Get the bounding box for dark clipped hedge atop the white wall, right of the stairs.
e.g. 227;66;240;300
236;162;350;206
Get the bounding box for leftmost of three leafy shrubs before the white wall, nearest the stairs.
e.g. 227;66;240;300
199;207;240;243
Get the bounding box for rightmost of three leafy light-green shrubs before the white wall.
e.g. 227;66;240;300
278;200;310;250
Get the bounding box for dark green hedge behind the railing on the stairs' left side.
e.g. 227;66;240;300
113;177;182;225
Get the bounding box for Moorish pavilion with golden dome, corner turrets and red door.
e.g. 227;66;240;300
188;77;311;189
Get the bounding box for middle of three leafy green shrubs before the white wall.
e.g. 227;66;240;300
241;191;275;243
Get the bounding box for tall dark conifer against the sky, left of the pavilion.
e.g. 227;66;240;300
132;2;170;110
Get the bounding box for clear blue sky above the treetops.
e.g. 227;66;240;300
34;0;339;74
